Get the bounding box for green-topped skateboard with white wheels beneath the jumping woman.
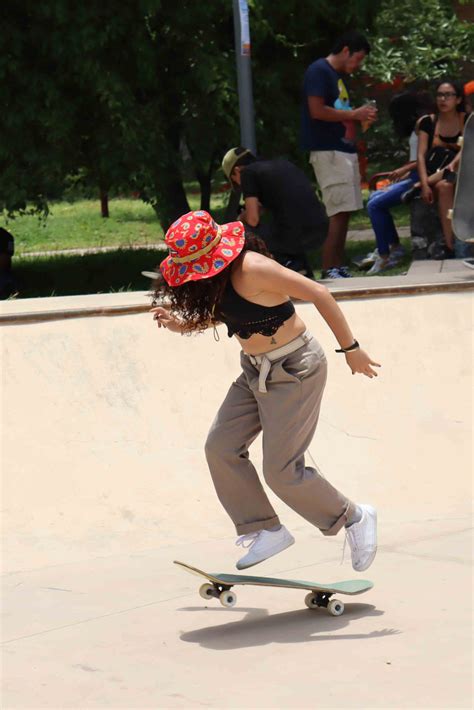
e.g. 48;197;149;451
174;560;374;616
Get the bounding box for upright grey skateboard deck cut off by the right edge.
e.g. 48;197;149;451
451;114;474;242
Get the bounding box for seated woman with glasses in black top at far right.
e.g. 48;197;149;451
417;79;466;257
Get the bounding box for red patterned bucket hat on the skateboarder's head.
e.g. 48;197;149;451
160;210;245;286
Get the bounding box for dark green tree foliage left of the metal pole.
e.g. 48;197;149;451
0;0;239;223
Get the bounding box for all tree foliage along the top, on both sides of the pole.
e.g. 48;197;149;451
4;0;472;231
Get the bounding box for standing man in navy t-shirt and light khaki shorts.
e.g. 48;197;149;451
302;32;377;278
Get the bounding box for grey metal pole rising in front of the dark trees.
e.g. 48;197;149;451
233;0;257;155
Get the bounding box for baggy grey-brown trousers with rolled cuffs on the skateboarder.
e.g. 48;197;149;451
206;333;354;535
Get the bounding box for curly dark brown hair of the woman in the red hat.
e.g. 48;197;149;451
152;230;273;333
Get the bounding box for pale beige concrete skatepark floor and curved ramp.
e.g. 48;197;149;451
0;292;473;710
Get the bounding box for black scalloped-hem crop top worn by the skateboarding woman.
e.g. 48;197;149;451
217;278;295;340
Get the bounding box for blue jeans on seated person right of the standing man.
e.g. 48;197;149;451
367;170;419;256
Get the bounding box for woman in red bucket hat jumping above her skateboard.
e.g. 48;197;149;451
151;211;379;572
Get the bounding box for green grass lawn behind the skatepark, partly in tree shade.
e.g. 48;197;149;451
0;194;410;298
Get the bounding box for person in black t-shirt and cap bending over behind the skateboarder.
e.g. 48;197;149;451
222;147;328;279
